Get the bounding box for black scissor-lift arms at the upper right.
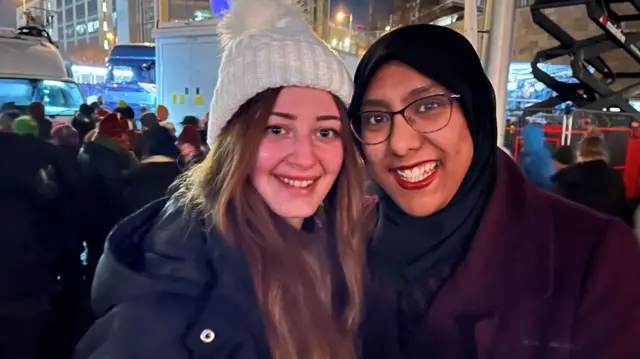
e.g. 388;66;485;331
530;0;640;112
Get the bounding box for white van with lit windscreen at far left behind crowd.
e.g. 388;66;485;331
0;26;84;120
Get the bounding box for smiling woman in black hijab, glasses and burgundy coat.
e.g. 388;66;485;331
350;25;640;359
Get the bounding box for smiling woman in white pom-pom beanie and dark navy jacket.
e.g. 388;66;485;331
75;0;364;359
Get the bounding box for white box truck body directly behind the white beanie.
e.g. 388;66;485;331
153;19;359;131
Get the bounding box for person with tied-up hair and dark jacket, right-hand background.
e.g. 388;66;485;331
553;133;633;226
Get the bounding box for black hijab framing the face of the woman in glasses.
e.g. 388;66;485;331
349;25;497;338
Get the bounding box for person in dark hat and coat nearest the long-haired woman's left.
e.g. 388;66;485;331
124;126;180;214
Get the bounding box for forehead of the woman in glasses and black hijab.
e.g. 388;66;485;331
363;61;445;105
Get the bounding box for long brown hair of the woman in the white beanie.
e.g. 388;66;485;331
175;89;365;359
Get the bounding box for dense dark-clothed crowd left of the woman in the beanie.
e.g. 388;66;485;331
0;94;208;359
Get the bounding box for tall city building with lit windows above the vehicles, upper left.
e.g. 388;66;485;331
16;0;118;65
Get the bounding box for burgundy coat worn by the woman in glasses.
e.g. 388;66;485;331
362;151;640;359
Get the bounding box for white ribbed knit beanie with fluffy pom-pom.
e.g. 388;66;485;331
207;0;353;145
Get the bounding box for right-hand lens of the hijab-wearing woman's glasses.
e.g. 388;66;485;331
405;95;451;133
